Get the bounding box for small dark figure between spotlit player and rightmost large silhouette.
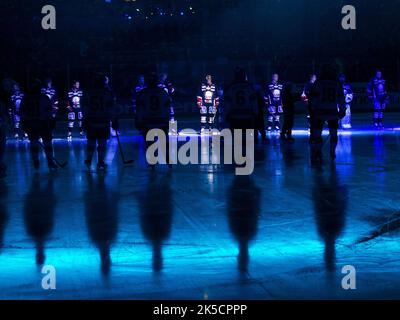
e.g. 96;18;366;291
281;82;301;141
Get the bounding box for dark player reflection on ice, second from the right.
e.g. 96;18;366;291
227;176;261;272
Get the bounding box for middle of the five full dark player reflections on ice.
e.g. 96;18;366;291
138;173;173;272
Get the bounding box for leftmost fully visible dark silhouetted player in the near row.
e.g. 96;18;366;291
20;80;57;171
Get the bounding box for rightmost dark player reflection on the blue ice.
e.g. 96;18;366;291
313;164;348;272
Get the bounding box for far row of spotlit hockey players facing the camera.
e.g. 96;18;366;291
3;71;389;140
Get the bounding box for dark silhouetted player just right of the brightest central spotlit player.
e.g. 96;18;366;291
224;68;258;131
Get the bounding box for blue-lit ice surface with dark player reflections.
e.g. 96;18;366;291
0;114;400;299
